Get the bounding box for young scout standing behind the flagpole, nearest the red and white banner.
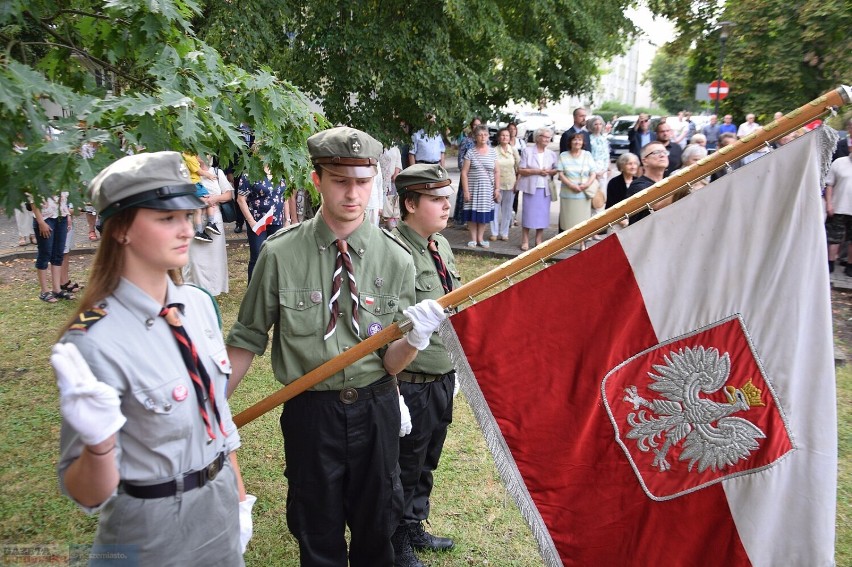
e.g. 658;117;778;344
393;164;460;567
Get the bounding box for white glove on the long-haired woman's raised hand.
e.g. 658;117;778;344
50;343;127;445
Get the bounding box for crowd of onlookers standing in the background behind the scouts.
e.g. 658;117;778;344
15;108;844;303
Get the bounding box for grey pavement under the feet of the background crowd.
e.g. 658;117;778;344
0;160;852;291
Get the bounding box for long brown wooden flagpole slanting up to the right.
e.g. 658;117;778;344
234;85;852;427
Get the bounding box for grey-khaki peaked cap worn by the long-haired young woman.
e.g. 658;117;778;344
89;152;206;219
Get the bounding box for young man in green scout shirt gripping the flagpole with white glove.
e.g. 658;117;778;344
227;127;444;567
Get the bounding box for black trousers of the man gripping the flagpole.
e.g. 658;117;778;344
281;378;402;567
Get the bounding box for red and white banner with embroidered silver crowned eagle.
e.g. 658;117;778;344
444;132;837;567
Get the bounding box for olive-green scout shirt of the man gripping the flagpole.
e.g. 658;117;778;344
227;214;414;390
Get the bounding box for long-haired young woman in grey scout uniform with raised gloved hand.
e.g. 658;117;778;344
51;152;248;566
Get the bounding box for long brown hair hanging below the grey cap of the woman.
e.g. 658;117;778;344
59;207;183;336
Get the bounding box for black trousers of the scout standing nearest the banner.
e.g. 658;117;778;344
399;376;455;524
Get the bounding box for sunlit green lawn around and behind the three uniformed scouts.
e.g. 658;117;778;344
0;247;852;567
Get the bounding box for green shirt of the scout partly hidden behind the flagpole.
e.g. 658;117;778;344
393;222;461;374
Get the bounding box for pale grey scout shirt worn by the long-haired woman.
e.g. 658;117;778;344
58;279;240;511
